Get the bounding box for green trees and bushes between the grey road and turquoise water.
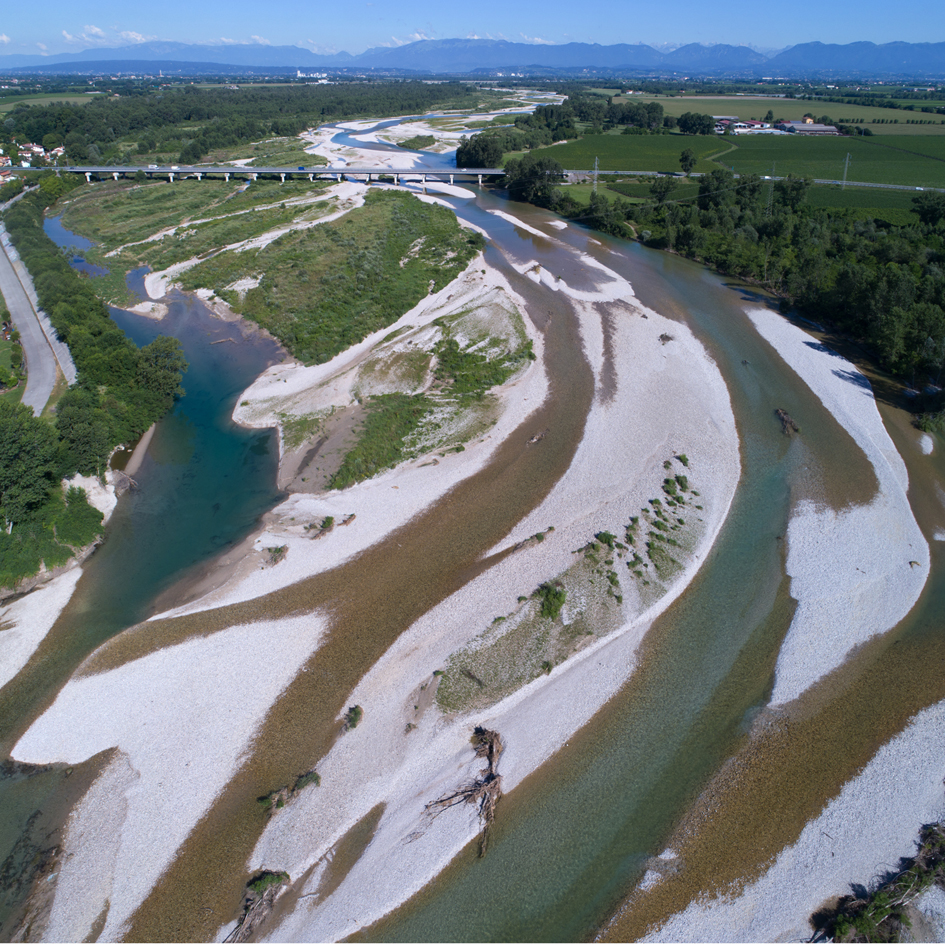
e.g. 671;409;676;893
0;181;186;587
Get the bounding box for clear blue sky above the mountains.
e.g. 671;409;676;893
0;0;945;55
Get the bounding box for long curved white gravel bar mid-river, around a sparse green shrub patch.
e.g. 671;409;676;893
234;256;740;940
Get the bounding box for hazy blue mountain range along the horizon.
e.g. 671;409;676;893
0;39;945;77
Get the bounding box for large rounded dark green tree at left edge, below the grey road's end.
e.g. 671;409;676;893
0;400;59;529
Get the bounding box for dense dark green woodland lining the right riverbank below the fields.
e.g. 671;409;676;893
505;154;945;412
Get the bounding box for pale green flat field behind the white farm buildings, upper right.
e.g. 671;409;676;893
614;95;945;137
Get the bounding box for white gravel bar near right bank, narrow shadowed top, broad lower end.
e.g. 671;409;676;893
748;309;929;706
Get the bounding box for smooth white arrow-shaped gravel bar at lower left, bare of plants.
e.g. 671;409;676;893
12;615;324;941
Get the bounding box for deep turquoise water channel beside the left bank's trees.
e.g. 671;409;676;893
0;251;282;922
